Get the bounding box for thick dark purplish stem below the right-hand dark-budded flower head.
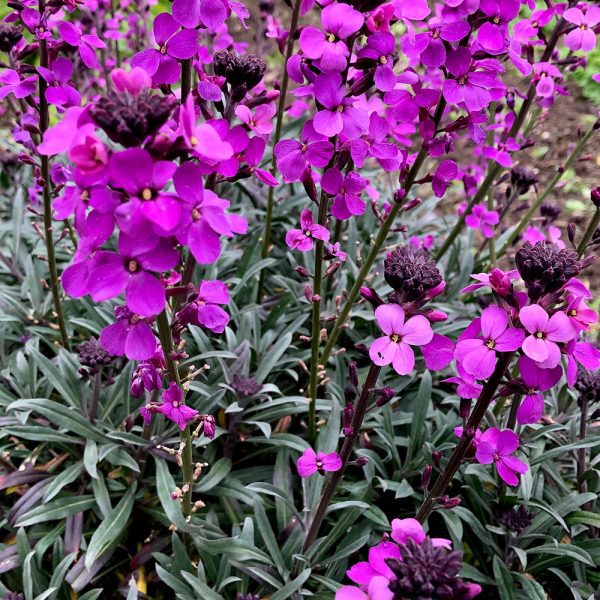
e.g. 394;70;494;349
417;352;515;523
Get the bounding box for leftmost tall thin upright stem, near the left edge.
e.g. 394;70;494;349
38;0;70;350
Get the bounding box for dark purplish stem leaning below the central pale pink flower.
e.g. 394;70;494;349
302;365;381;554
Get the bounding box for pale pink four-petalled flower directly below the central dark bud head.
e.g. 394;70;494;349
369;304;433;375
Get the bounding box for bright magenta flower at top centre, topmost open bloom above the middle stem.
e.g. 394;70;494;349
300;3;364;73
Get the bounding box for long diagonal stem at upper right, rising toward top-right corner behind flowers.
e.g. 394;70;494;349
433;18;565;261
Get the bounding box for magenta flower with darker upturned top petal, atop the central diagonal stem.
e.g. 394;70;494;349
442;47;498;111
